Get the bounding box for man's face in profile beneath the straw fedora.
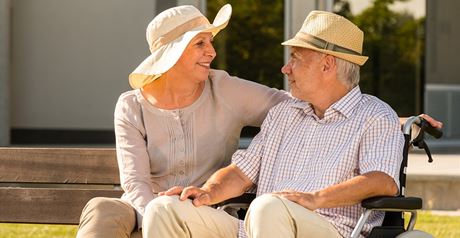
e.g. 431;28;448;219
281;47;325;101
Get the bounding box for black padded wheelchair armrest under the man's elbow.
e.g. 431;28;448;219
361;196;422;210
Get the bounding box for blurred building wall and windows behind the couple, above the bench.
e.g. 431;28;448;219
0;0;460;151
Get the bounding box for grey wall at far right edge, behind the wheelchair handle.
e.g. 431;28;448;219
425;0;460;146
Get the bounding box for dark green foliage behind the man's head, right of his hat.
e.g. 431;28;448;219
335;0;425;115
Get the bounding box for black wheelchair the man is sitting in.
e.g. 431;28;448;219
217;116;442;238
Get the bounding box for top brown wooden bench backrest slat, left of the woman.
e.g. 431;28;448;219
0;147;120;185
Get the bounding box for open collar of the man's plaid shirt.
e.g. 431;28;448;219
292;86;362;118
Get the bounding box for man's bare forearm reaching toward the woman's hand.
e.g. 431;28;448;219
202;164;253;204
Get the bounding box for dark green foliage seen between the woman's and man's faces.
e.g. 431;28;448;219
207;0;284;88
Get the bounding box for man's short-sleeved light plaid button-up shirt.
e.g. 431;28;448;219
232;87;404;237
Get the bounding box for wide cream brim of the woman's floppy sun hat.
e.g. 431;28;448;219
129;4;232;89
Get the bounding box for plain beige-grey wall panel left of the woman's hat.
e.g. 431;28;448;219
11;0;162;129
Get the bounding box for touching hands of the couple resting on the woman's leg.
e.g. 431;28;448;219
158;186;211;207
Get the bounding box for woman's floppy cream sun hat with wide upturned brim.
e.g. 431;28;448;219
129;4;232;88
